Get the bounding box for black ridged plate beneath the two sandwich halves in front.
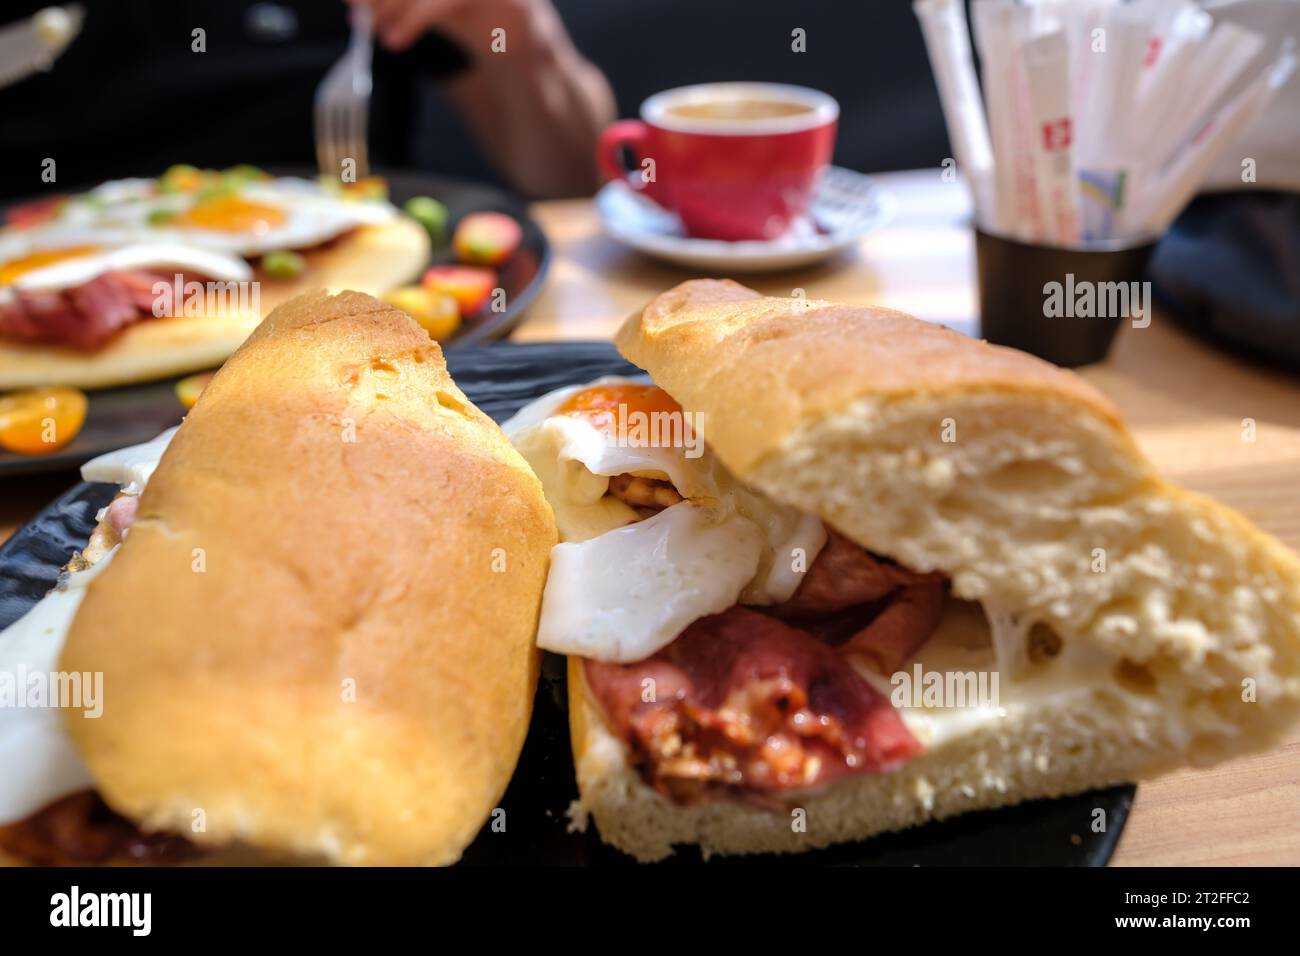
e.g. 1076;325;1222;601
0;342;1135;866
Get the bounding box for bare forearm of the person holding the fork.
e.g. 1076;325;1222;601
447;3;615;198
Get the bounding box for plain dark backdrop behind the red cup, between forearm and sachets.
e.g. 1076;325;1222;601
444;0;952;184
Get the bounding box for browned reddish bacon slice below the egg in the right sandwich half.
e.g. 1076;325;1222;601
584;606;920;803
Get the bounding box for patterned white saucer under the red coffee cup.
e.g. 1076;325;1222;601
595;166;894;272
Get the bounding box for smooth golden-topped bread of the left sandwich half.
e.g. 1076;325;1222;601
61;293;555;865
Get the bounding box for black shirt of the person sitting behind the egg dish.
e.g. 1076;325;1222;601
0;0;468;198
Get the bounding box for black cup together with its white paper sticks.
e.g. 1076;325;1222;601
913;0;1296;365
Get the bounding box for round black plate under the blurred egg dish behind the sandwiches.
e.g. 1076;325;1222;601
0;169;551;479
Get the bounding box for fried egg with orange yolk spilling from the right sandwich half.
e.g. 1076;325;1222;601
503;377;826;662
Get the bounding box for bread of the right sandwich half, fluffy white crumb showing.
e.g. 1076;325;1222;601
569;280;1300;860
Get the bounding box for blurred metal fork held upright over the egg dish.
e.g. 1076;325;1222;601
315;7;373;179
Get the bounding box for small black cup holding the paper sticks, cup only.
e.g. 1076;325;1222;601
975;229;1156;365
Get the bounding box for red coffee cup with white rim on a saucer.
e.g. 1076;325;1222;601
595;83;840;239
